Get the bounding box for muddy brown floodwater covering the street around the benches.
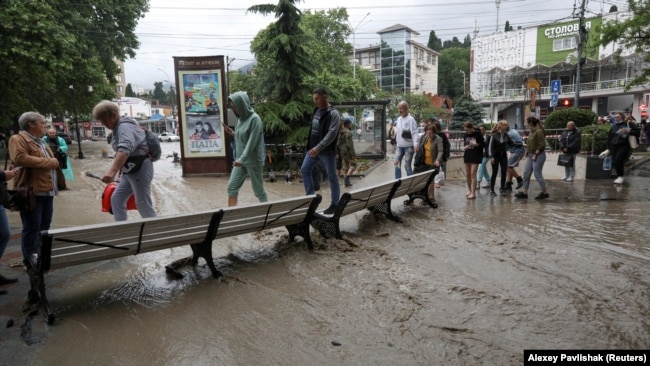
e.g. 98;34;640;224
0;142;650;365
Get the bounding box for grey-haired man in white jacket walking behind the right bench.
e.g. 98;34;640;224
395;101;420;179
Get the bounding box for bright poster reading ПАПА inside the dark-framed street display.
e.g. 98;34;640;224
179;69;226;157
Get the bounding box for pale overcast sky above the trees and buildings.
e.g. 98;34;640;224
125;0;627;89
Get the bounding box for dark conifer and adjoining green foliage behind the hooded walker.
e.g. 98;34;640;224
243;0;376;145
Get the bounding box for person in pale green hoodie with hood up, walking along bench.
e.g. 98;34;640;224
228;92;268;206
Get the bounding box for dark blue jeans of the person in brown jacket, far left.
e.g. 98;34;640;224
20;196;54;265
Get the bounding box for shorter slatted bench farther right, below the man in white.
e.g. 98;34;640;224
310;169;438;239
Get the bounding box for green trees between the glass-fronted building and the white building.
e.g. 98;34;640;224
438;47;470;101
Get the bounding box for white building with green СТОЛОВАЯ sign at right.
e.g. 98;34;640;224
470;13;650;126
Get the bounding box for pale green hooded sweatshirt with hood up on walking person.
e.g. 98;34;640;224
228;92;266;166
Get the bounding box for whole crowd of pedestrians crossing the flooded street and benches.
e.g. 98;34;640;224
0;87;650;295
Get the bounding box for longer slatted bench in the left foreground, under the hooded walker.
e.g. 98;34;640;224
27;195;321;324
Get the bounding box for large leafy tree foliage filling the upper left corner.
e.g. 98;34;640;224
0;0;149;128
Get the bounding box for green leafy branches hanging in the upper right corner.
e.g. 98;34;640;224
600;0;650;89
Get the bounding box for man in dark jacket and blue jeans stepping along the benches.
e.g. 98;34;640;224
300;87;341;215
